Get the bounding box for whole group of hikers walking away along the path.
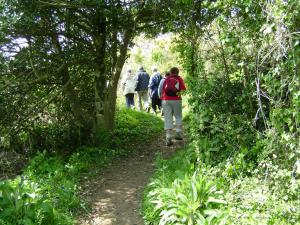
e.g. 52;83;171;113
122;66;186;146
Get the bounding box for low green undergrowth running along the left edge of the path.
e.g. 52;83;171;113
0;109;162;225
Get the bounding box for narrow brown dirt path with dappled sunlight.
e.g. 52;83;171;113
77;136;183;225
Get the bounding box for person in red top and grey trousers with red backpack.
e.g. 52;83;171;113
158;67;186;146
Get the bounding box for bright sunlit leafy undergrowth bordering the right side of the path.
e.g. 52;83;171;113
142;144;300;225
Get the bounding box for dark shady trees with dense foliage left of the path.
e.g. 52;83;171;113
0;0;173;152
